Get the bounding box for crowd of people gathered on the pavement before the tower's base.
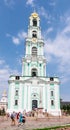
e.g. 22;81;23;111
6;109;48;127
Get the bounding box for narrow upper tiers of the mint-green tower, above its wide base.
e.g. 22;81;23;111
22;12;46;77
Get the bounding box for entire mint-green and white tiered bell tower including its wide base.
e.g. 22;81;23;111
8;12;61;115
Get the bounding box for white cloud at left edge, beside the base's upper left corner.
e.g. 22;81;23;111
0;60;19;96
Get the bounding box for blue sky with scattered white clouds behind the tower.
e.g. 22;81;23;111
0;0;70;101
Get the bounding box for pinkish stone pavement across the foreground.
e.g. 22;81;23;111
0;116;70;130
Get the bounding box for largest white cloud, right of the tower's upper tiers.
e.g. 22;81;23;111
44;17;70;83
